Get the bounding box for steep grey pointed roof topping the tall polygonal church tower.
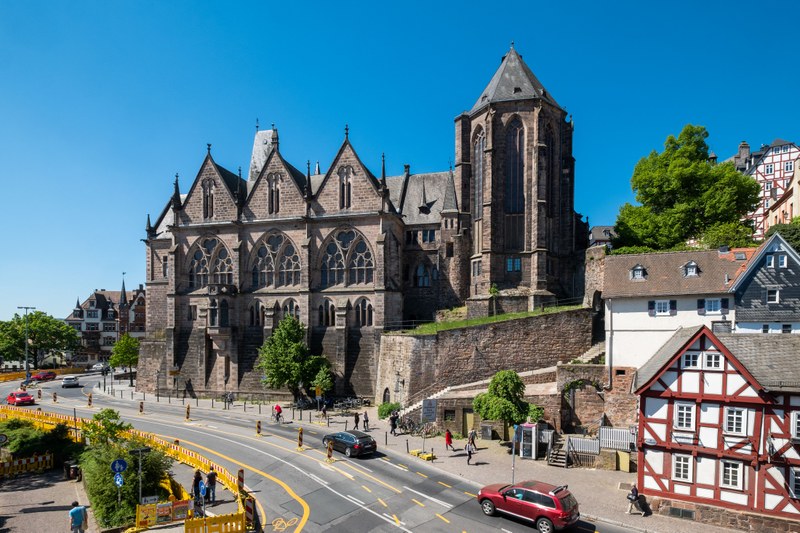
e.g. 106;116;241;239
470;45;560;114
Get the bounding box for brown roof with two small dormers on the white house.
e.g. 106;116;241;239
603;248;755;298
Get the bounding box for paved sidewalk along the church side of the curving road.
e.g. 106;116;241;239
95;382;735;533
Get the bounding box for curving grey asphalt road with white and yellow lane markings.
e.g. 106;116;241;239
0;375;635;533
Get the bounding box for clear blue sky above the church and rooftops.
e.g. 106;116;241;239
0;0;800;320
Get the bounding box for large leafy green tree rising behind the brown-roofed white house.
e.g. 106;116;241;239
614;124;759;250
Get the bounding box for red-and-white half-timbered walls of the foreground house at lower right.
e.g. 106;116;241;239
638;328;800;520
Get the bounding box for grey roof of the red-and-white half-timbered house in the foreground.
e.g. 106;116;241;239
636;326;800;392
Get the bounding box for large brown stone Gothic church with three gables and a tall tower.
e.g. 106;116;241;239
139;47;588;397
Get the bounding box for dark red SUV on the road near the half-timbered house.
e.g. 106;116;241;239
478;481;580;533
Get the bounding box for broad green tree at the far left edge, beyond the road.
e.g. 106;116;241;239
0;311;80;368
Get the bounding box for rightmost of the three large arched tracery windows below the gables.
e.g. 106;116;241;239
320;230;375;288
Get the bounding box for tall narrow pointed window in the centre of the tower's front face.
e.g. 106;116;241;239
503;118;525;251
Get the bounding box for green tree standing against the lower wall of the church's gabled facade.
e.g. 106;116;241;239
256;315;330;400
